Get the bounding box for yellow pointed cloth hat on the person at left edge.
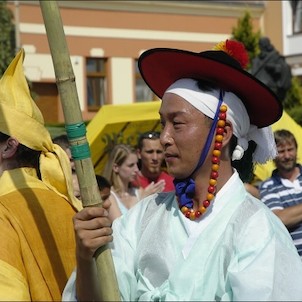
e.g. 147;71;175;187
0;49;51;151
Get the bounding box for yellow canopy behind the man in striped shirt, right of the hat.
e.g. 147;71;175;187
255;111;302;181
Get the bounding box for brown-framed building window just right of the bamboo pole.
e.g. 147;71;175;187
86;58;107;111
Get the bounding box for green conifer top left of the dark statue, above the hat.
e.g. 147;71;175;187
232;11;260;69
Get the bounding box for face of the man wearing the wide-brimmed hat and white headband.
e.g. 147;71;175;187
159;93;212;179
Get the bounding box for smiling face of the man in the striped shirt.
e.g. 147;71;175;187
274;142;297;172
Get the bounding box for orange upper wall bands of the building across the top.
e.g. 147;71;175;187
10;2;259;58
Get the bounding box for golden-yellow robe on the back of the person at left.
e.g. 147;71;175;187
0;168;76;301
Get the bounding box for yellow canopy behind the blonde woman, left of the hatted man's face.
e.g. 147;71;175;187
87;101;160;174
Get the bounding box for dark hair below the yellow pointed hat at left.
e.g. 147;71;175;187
0;132;41;177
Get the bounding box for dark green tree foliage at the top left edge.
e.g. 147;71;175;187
0;0;16;76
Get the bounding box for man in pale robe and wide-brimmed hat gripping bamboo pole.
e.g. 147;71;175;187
63;40;302;301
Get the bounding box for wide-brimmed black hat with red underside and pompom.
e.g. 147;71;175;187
138;40;282;128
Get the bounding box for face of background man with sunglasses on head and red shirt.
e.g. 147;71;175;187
138;138;164;175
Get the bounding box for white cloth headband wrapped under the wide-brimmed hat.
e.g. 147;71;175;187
165;79;277;163
